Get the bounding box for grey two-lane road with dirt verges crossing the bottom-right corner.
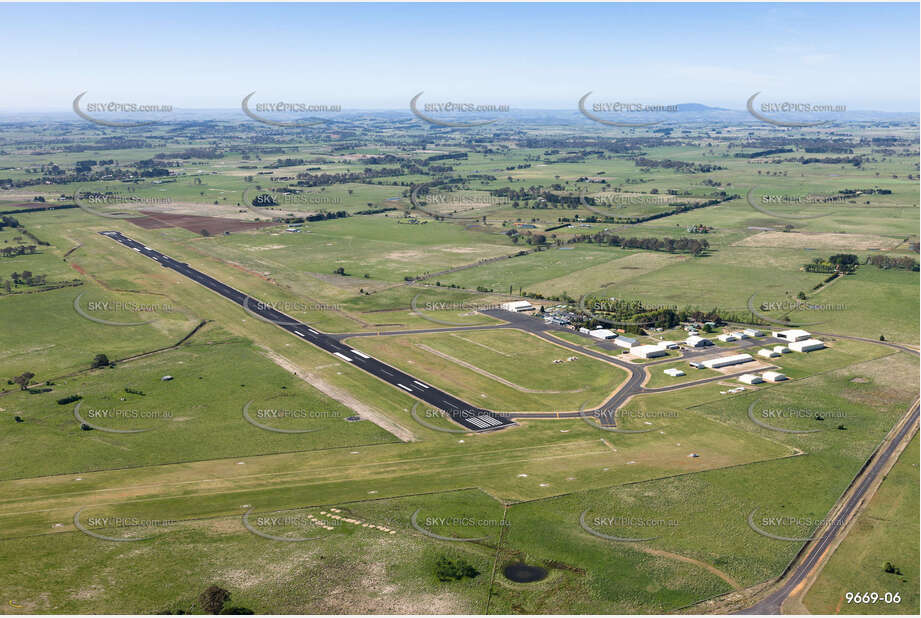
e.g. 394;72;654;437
737;400;918;615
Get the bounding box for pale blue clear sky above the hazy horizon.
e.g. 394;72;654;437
0;3;919;111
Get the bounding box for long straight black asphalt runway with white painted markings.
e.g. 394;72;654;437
100;231;515;432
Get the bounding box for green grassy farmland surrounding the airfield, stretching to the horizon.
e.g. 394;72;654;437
0;118;919;614
